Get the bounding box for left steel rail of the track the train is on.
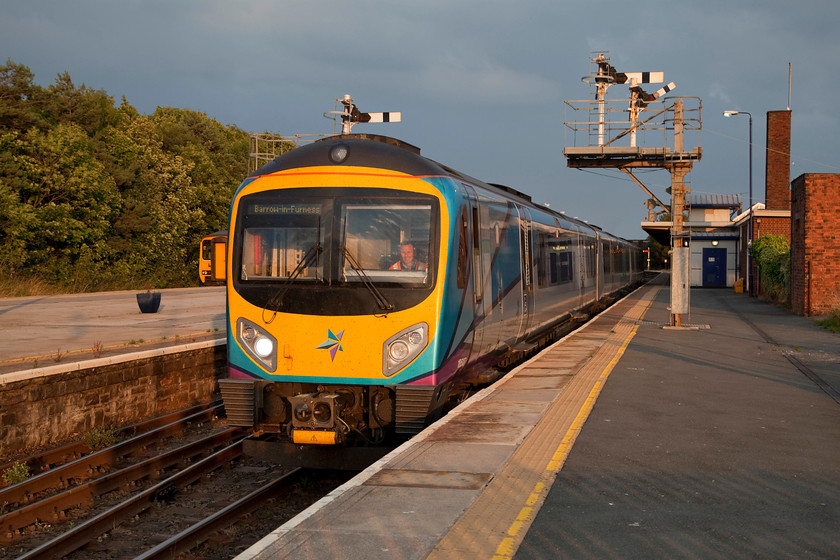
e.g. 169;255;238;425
17;438;245;560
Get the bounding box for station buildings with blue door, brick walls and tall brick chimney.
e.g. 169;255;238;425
642;110;840;316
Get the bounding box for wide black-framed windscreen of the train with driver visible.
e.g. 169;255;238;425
233;188;440;315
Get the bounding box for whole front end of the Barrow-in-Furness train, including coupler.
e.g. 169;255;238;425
220;159;452;444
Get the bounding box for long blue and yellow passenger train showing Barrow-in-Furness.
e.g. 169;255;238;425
219;134;643;447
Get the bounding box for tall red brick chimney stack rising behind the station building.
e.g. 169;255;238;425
764;110;790;210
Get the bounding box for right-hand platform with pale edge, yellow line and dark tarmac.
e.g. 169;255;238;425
237;276;840;560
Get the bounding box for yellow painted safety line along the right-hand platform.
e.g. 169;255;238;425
493;325;639;560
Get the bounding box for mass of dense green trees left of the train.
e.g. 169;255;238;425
0;60;248;295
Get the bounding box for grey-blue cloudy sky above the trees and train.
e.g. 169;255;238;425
0;0;840;239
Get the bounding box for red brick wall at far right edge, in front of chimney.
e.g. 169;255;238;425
791;173;840;315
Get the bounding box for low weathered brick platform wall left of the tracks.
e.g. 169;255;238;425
0;344;227;456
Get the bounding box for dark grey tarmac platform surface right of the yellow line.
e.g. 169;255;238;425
515;289;840;560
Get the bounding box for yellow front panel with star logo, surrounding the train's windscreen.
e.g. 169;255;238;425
228;167;449;382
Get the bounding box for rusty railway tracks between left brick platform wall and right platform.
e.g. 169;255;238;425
0;404;349;559
